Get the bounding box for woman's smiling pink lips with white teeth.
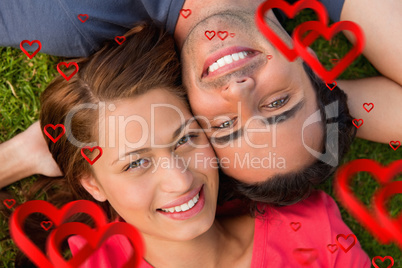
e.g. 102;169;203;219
157;186;205;220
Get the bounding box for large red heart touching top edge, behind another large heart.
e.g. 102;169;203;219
256;0;328;61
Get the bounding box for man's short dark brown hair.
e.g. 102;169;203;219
220;63;356;215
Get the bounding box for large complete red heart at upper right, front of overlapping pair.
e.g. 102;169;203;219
293;21;365;83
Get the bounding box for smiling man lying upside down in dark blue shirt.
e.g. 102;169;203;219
0;0;402;194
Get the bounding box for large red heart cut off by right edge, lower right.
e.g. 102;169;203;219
373;181;402;249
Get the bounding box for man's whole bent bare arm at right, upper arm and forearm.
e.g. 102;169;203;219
337;0;402;143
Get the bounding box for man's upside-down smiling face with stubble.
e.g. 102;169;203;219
179;2;323;183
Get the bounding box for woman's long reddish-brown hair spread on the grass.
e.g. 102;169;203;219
2;23;185;267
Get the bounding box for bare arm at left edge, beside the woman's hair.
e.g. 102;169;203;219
0;122;62;188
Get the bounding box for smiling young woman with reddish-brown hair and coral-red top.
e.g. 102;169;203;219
8;22;370;268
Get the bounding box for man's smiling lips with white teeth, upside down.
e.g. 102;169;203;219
201;46;261;78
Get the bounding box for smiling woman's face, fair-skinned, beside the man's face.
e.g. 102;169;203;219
81;89;218;240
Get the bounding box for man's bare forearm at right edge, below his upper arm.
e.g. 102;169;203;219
337;77;402;143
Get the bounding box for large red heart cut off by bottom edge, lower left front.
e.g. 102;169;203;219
47;222;145;268
